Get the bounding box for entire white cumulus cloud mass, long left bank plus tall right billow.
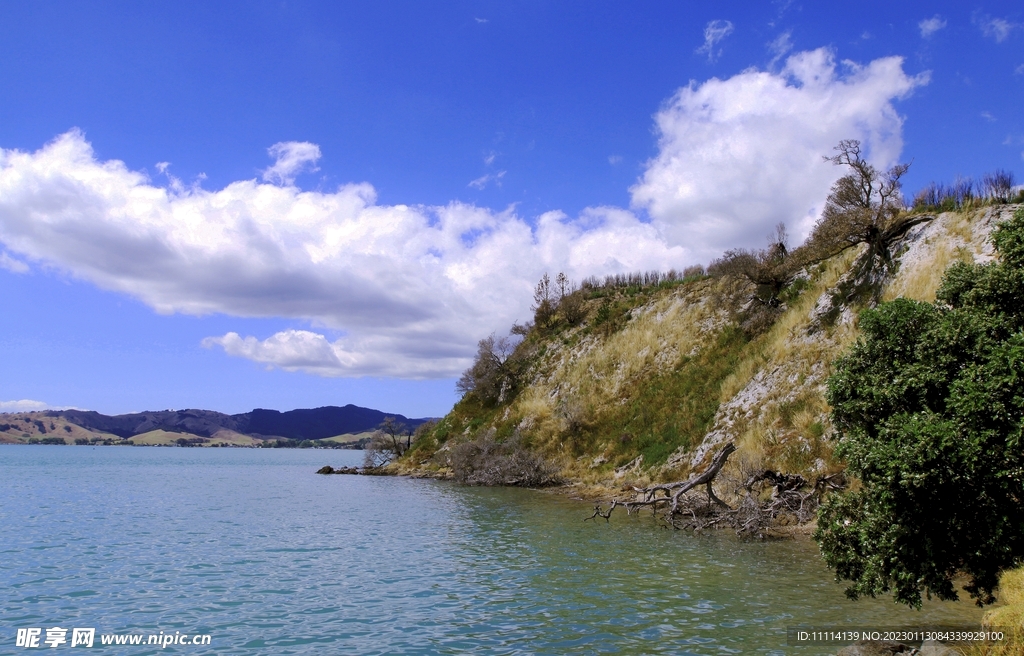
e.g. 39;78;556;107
0;50;927;378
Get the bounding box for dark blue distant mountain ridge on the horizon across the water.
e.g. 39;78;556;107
45;403;428;440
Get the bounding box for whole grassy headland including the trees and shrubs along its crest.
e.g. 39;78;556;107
392;152;1024;507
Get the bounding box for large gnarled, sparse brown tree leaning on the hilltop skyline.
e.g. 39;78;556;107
798;139;934;301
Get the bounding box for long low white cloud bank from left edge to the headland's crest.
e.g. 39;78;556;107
0;131;694;378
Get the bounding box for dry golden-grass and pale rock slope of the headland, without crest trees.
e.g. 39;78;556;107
399;205;1020;485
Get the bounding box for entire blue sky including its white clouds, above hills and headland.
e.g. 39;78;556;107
0;1;1024;416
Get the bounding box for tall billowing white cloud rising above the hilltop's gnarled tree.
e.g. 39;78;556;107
631;49;928;261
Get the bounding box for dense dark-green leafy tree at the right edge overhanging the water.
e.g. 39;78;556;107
814;210;1024;607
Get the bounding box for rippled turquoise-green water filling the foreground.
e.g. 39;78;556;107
0;446;980;654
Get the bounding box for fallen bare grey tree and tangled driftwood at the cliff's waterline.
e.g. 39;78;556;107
584;443;846;536
